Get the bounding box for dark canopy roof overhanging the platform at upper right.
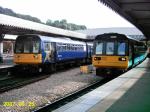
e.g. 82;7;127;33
98;0;150;40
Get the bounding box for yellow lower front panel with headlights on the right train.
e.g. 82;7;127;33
92;55;128;69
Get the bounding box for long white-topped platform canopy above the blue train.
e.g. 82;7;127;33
0;14;87;39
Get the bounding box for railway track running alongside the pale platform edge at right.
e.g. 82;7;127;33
32;76;116;112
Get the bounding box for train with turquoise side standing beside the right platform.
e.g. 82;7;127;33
92;33;147;76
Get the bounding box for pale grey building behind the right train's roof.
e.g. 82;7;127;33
77;27;145;40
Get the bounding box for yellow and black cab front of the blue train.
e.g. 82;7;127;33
14;35;42;64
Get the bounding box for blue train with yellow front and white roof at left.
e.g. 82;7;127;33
12;34;93;72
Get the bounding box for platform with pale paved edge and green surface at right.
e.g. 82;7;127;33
53;58;150;112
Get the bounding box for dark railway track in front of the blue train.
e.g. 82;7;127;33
0;69;50;93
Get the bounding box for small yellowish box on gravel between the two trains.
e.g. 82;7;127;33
80;65;94;74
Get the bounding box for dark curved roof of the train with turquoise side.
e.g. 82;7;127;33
95;33;140;42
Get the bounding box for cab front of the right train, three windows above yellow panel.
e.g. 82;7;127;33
93;35;128;69
